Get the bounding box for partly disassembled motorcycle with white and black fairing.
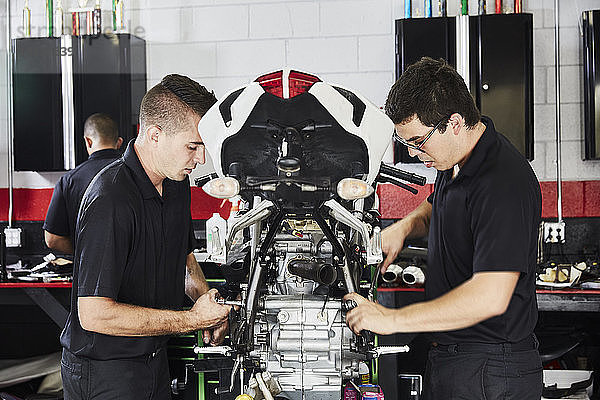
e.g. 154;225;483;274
198;70;394;400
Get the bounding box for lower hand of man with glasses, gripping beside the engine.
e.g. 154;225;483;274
344;293;396;335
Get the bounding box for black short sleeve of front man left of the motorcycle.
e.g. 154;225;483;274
75;194;134;299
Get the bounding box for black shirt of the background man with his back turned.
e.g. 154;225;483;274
43;149;121;239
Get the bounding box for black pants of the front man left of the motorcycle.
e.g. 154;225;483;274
60;349;171;400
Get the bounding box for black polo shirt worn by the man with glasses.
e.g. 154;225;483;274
425;117;541;344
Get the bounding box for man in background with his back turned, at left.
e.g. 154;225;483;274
43;113;123;254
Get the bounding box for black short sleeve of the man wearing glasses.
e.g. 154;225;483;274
469;183;537;273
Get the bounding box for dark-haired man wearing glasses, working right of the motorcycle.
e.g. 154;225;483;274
346;58;542;400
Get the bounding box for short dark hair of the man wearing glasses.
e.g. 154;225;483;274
385;57;481;128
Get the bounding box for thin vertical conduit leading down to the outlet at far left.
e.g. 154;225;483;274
6;0;15;228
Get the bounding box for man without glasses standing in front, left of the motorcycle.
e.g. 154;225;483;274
61;75;229;400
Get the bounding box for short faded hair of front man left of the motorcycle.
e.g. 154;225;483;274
140;74;217;135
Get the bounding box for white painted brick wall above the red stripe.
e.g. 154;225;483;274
0;0;600;187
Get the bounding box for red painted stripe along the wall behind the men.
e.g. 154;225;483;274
0;181;600;221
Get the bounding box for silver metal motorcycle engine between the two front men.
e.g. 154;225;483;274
250;220;364;400
